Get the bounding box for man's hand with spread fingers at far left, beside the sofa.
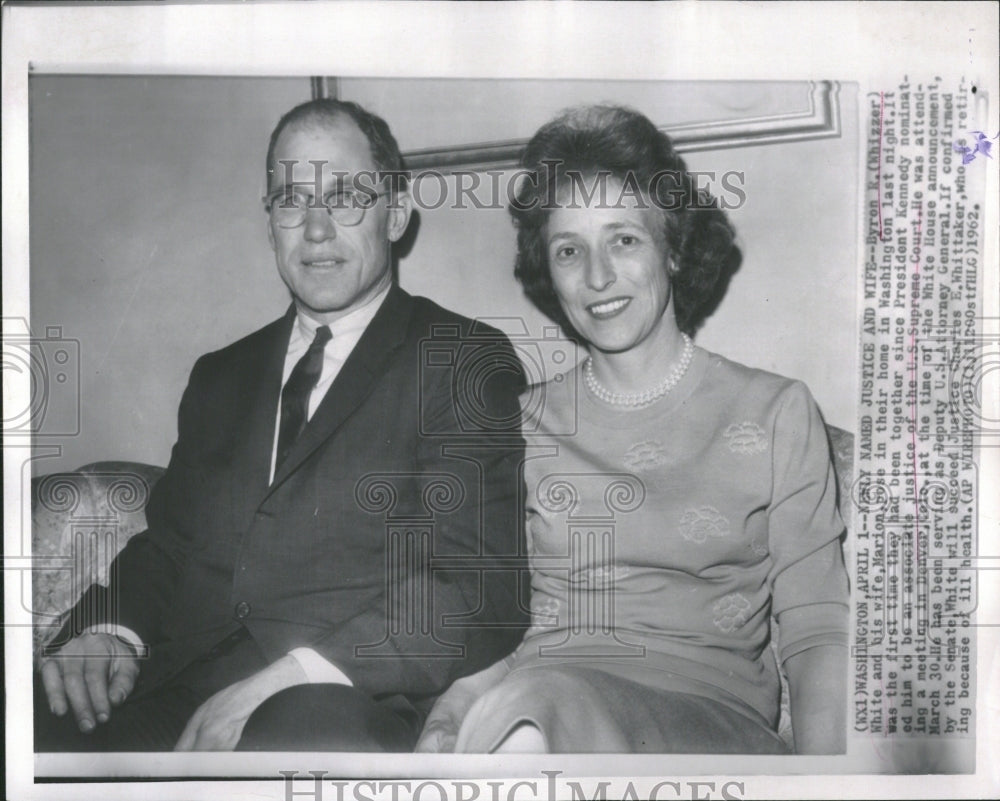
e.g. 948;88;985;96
42;634;139;733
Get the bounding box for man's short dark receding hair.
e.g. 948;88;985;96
265;97;406;189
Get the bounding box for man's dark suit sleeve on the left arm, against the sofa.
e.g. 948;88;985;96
50;359;206;649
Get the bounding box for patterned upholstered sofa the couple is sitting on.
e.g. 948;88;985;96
31;426;854;743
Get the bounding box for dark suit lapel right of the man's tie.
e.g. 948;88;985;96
267;286;413;496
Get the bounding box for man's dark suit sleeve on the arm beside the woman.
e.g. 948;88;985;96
310;335;528;695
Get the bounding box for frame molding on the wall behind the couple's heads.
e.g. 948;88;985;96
358;78;840;175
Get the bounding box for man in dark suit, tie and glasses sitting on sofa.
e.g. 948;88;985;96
36;100;526;751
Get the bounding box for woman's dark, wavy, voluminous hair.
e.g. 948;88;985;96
510;105;741;339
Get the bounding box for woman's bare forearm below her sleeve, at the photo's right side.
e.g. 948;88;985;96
785;645;847;754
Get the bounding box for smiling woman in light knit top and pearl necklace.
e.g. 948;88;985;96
418;106;848;754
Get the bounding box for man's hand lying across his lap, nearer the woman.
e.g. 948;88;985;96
174;656;308;751
